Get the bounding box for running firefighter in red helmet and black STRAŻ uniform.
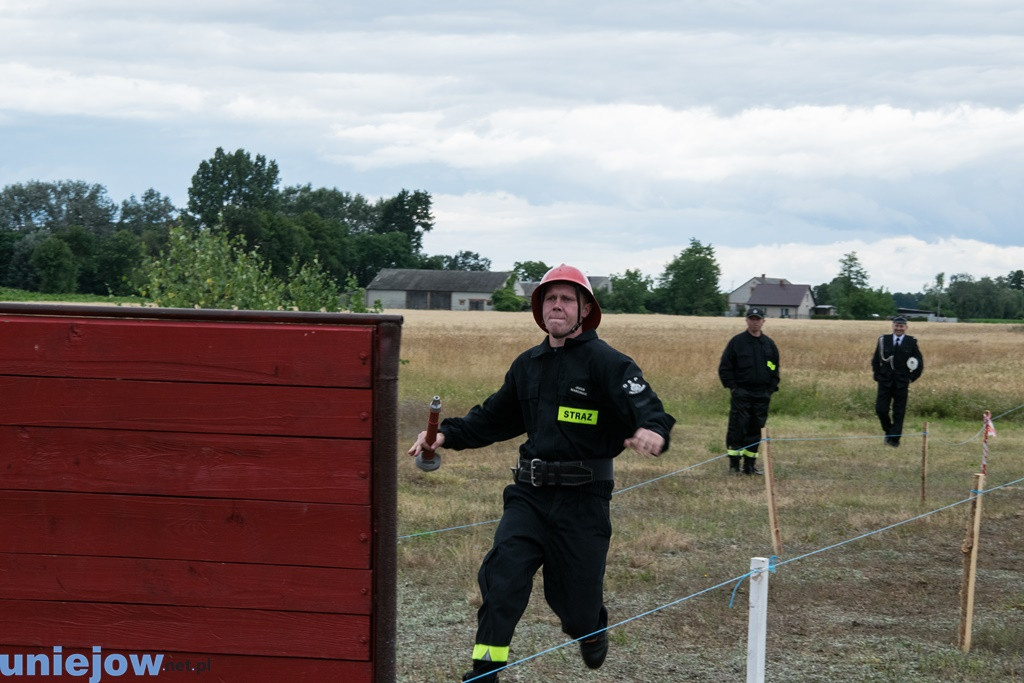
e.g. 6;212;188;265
409;264;675;682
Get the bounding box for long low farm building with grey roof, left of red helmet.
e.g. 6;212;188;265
367;268;523;310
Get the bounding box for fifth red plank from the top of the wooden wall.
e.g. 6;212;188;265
0;553;373;614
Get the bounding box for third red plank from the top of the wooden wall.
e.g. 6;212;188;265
0;426;371;505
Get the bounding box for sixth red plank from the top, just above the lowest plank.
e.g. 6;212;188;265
0;600;370;660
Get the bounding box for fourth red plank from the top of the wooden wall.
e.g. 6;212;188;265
0;490;371;569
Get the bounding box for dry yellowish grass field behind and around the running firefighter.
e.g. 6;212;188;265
388;310;1024;683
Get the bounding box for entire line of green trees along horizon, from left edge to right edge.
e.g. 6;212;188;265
0;147;1024;319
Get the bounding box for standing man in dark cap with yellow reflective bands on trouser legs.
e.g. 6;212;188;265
718;306;778;474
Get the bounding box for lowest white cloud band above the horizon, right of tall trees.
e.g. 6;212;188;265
424;193;1024;292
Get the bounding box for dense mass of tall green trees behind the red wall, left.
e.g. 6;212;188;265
0;147;490;307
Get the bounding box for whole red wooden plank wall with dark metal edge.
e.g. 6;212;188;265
0;304;401;683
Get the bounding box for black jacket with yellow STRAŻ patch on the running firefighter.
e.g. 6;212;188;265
440;330;676;462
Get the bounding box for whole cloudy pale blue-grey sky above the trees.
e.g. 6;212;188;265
0;0;1024;293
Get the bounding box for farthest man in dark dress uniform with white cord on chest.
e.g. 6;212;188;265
871;315;925;449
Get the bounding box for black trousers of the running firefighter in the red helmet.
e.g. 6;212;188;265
476;481;613;647
